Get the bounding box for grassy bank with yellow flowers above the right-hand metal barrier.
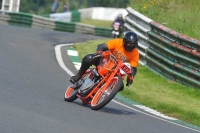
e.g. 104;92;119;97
129;0;200;39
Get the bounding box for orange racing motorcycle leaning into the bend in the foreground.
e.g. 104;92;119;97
64;51;132;110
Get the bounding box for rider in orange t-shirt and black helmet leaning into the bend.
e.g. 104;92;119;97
70;31;139;86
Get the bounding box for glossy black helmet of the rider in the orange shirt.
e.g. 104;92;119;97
123;31;138;52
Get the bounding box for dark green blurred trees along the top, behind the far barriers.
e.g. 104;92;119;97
19;0;129;14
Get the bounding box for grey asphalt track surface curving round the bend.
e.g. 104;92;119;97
0;24;199;133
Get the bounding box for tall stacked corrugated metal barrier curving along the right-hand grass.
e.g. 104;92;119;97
125;7;200;89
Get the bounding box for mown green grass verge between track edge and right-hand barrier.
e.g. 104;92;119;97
74;39;200;126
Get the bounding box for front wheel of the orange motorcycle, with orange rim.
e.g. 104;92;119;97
91;76;123;110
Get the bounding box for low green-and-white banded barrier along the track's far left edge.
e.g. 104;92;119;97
0;11;111;37
